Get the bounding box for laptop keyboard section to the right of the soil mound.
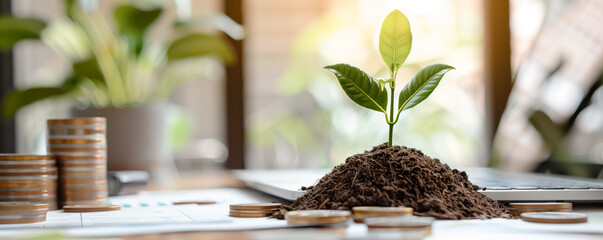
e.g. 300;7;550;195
467;170;603;191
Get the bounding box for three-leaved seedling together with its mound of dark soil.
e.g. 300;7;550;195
275;10;510;219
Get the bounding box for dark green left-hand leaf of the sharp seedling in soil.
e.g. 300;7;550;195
325;63;387;113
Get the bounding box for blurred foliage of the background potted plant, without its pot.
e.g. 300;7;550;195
0;0;235;116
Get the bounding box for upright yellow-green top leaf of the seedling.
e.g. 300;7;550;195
379;10;412;72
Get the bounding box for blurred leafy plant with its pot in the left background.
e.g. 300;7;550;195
0;1;240;175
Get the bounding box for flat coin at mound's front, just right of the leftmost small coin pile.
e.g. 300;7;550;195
285;210;352;224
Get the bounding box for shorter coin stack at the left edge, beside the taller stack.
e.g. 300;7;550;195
0;154;57;210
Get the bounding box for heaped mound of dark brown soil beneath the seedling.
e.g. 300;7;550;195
274;144;512;219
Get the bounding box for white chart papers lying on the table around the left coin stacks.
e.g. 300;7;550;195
0;189;287;238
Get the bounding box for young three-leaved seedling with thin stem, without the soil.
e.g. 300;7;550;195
325;10;454;147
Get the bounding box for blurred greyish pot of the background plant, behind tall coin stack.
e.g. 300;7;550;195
72;102;175;178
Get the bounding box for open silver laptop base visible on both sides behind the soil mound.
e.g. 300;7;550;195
234;168;603;202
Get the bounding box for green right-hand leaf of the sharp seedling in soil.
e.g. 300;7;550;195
398;64;454;113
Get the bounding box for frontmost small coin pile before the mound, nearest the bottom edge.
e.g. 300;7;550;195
364;216;435;236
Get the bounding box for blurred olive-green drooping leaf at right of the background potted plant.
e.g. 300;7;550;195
167;33;235;63
